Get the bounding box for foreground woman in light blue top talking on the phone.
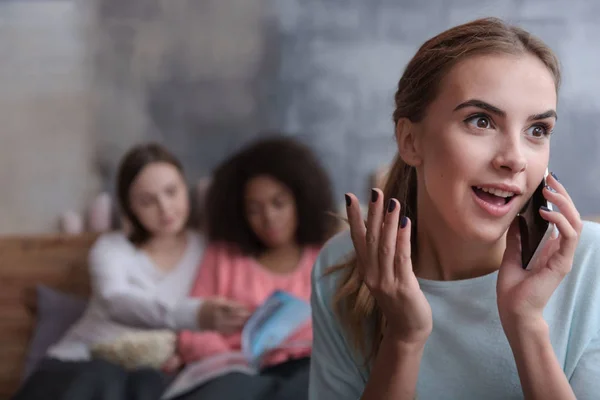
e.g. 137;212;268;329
309;19;600;400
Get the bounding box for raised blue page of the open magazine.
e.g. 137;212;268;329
242;291;311;368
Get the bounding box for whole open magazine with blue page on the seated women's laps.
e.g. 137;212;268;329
162;291;311;400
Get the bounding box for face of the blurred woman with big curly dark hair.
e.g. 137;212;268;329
244;175;298;248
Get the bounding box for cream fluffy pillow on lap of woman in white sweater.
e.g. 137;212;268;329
90;330;177;370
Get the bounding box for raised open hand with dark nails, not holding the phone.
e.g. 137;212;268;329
346;189;433;344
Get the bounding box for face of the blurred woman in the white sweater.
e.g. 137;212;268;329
129;162;190;236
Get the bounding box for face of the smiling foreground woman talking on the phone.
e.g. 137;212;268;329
411;51;556;243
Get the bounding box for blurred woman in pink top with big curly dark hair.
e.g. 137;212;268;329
179;137;337;400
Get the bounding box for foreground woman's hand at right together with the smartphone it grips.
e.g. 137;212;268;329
496;169;583;334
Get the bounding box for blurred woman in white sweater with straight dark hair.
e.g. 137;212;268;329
16;144;247;400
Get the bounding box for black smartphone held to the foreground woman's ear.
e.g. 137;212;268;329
519;170;554;269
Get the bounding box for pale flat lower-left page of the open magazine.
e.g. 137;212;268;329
161;352;258;400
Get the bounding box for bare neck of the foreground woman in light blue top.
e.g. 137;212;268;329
414;207;506;281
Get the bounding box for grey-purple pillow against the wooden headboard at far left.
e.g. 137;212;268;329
23;285;87;379
